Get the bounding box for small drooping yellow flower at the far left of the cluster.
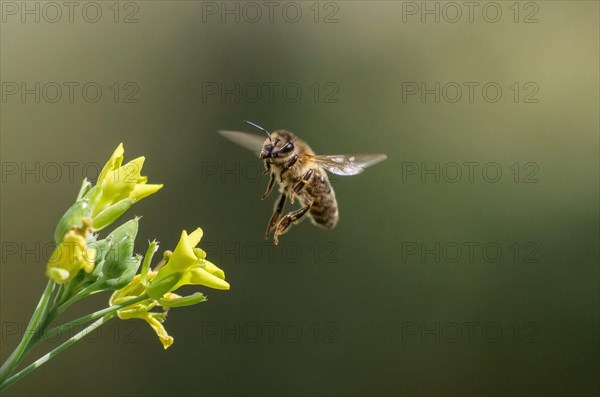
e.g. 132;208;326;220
46;230;96;284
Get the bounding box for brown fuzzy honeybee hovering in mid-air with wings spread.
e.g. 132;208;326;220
219;120;387;245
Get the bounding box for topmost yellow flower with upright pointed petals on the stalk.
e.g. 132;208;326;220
90;143;163;218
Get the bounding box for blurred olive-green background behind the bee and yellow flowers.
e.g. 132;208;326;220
0;1;600;396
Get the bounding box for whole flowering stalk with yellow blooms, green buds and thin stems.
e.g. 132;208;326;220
0;144;229;390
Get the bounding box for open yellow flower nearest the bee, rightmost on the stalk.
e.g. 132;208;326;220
148;228;229;299
